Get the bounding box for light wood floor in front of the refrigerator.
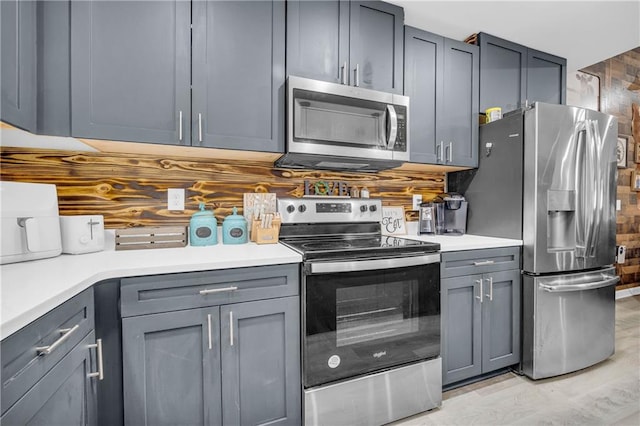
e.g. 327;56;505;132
392;296;640;426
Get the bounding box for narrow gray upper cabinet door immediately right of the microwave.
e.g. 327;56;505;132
404;27;444;164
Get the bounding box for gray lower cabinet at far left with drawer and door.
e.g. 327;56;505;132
0;288;101;425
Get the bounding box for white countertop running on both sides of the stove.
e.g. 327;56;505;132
0;226;522;339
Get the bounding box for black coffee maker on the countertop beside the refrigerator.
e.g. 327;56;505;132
418;193;467;235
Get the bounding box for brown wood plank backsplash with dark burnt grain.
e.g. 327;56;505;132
0;146;445;228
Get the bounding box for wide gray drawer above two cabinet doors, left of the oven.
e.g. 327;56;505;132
120;263;300;317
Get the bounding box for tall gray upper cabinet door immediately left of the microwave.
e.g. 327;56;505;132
192;0;285;152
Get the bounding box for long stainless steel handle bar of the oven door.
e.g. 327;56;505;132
307;253;440;274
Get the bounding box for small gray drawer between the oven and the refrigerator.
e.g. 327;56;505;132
441;247;520;278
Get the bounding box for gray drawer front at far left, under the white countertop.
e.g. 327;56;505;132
0;287;94;413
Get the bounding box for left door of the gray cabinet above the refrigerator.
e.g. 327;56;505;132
478;33;527;114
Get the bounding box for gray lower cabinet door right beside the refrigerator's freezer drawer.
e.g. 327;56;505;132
482;270;521;373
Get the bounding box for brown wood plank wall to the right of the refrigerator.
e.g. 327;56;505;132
582;47;640;288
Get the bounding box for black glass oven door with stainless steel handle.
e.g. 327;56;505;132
302;254;440;388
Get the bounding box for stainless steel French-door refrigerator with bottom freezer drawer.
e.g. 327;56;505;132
449;103;619;379
